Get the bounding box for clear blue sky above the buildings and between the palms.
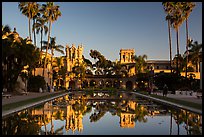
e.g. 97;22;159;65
2;2;202;61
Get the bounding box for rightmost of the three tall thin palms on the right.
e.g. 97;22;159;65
183;2;195;77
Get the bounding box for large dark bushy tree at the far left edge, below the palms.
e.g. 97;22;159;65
2;30;39;91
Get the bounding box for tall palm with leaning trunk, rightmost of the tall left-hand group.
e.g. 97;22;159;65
40;2;61;76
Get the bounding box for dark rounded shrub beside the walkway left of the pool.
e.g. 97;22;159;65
28;75;46;92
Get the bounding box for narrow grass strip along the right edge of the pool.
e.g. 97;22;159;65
136;91;202;110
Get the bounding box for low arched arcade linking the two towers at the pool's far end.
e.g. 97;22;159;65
69;75;136;90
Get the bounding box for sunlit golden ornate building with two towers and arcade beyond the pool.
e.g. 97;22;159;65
34;44;199;89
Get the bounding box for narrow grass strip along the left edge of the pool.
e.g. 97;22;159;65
2;92;65;111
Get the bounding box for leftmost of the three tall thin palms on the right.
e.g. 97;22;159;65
162;2;172;72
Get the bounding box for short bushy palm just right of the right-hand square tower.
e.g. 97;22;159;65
135;54;147;73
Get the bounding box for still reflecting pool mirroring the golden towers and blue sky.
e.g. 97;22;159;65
2;93;202;135
